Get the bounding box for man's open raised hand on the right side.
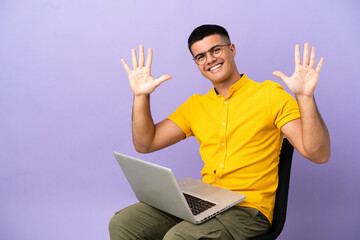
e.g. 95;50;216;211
273;43;324;98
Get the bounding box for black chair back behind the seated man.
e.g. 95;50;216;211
251;138;294;240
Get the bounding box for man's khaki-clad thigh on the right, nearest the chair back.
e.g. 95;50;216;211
164;207;270;240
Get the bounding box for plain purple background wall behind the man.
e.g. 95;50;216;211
0;0;360;240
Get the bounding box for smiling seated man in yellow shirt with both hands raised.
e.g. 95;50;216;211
110;25;330;239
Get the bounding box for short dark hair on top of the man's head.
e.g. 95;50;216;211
188;24;230;53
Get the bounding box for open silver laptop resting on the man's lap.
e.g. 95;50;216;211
114;152;246;224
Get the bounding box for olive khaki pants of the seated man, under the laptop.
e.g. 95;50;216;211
109;203;270;240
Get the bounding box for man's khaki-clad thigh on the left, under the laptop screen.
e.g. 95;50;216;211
109;203;180;240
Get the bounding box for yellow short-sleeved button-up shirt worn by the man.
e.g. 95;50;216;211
169;75;300;222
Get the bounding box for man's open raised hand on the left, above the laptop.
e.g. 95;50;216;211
121;45;172;96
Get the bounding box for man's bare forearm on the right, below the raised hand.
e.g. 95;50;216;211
296;96;330;163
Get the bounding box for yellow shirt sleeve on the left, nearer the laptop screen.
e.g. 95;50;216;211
168;98;193;138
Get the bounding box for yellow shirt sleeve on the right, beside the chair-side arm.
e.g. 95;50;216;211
269;83;300;129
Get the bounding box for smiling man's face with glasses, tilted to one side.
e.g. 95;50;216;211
191;34;236;84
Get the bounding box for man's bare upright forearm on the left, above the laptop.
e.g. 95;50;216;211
132;95;155;153
